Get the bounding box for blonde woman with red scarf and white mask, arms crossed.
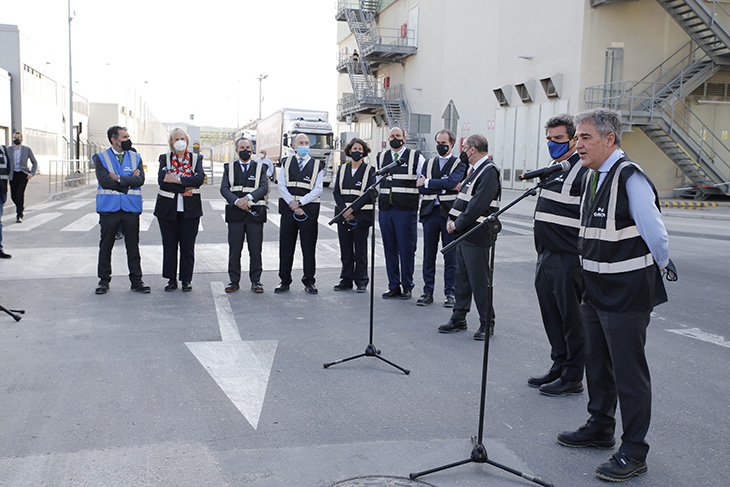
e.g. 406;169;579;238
155;128;205;292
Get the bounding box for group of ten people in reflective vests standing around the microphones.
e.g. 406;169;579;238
92;109;669;481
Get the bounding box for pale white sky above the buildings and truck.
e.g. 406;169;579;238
0;0;337;127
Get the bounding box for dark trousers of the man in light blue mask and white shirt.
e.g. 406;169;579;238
279;212;319;286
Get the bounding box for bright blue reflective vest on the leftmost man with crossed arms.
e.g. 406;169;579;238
96;148;142;213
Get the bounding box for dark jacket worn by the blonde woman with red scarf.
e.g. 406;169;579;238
154;153;205;220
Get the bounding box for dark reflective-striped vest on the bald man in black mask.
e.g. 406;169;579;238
376;149;421;211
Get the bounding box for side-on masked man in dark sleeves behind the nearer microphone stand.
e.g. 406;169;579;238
438;134;494;340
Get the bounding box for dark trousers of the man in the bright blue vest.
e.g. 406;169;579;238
97;211;142;284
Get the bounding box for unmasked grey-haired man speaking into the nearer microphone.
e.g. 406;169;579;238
558;108;669;481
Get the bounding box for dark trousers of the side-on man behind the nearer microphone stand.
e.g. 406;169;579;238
451;242;494;326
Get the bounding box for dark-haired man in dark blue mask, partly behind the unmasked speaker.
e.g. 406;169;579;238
527;113;587;396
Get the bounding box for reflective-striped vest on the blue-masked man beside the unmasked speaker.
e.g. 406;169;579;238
534;152;588;255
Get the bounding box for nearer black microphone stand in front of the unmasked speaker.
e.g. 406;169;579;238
409;180;553;487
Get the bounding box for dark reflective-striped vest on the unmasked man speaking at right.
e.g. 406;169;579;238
578;157;666;312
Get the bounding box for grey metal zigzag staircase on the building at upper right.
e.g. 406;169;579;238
585;0;730;199
